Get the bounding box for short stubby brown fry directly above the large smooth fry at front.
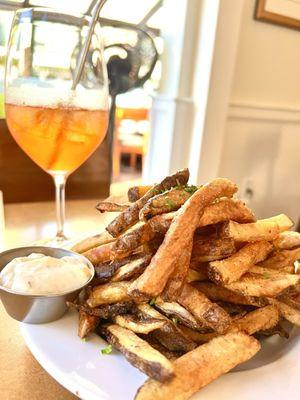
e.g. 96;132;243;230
178;284;231;333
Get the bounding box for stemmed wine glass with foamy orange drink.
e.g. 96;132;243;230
5;8;108;243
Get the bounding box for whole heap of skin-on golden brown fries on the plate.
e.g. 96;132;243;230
69;169;300;400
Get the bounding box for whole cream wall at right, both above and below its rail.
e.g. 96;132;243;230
219;0;300;223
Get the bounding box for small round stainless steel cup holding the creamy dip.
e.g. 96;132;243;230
0;246;95;324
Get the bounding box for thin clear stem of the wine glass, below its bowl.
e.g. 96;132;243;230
53;174;67;240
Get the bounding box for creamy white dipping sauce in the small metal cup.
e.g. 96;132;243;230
0;253;91;295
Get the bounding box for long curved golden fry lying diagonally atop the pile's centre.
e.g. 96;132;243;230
130;178;237;298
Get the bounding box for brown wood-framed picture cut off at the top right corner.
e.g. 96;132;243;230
255;0;300;30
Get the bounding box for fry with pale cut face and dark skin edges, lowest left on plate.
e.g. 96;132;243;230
99;324;174;382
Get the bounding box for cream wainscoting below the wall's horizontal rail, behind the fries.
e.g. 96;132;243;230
219;104;300;225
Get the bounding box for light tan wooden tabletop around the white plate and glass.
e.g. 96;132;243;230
0;200;120;400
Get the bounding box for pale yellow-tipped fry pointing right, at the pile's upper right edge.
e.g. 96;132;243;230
222;214;293;242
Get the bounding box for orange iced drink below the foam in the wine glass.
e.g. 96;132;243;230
6;103;108;174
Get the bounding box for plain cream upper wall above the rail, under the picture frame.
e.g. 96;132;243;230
231;0;300;108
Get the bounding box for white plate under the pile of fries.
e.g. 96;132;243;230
21;311;300;400
